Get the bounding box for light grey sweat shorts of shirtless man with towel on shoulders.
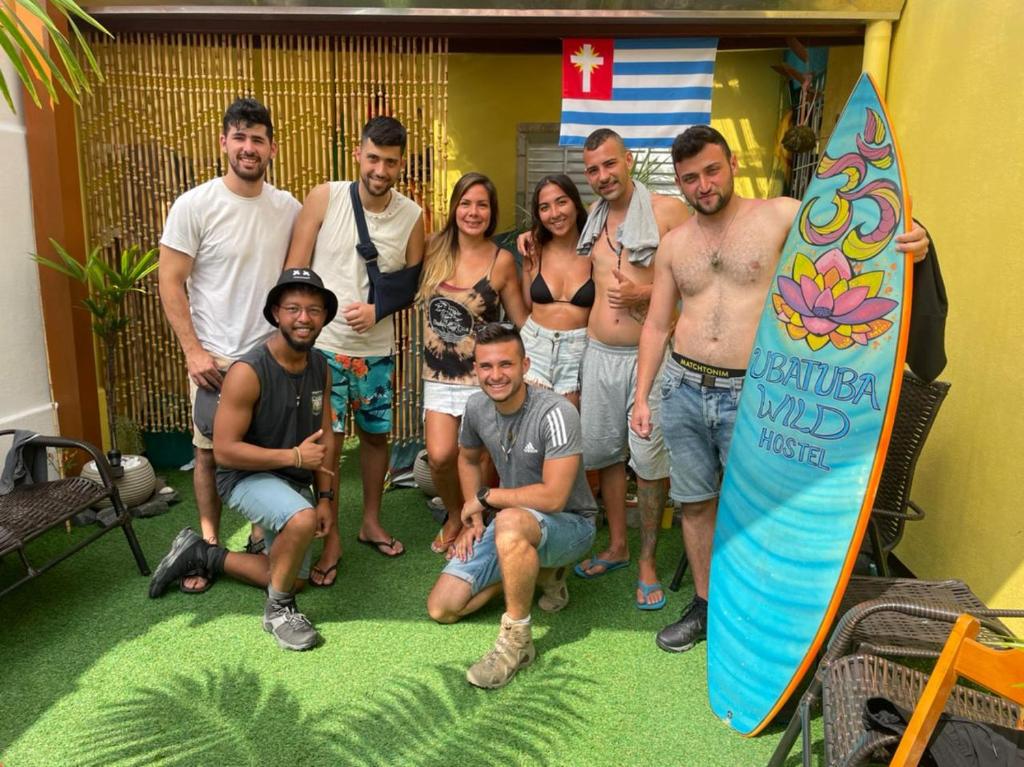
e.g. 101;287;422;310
580;338;669;479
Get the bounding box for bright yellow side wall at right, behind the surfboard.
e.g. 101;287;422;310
888;0;1024;607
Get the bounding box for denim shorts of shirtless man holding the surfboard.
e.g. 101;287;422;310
662;357;743;503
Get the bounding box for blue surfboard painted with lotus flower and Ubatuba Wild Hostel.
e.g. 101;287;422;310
708;75;911;735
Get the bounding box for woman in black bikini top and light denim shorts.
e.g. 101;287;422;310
522;174;595;408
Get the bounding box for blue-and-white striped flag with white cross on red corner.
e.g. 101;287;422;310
558;37;718;148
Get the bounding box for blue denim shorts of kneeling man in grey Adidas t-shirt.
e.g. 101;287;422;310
442;509;596;594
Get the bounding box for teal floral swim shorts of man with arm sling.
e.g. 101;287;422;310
316;349;394;434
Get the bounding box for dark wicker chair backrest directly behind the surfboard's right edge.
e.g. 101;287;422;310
865;373;949;578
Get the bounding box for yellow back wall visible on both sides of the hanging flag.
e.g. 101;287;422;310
437;50;781;230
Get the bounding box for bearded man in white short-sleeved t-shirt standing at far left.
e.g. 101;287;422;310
160;98;301;593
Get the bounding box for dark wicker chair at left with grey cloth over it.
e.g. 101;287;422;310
0;429;150;597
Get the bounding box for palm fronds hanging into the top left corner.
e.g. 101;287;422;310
0;0;111;112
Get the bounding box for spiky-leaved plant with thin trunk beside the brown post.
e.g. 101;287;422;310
33;240;159;454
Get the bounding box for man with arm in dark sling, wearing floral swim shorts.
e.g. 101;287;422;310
286;117;424;587
